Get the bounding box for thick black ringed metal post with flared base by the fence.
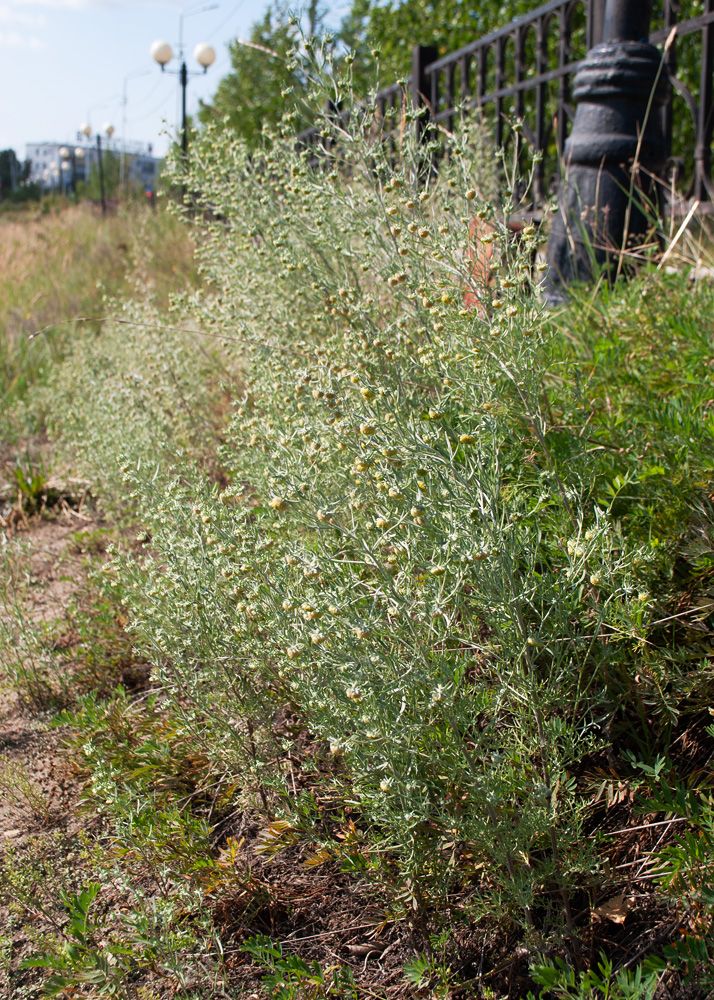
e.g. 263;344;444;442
547;0;671;303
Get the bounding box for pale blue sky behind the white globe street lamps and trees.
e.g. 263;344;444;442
0;0;342;159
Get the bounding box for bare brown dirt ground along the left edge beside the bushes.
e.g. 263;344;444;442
0;507;105;998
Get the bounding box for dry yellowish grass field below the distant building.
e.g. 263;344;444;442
0;204;197;430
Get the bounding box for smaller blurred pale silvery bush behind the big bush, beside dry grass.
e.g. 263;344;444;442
37;300;234;499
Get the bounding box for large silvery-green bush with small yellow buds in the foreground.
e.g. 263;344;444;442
96;84;660;922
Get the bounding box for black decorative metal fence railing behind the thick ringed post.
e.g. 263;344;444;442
300;0;714;211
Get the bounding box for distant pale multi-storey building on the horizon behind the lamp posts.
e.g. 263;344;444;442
26;136;162;191
